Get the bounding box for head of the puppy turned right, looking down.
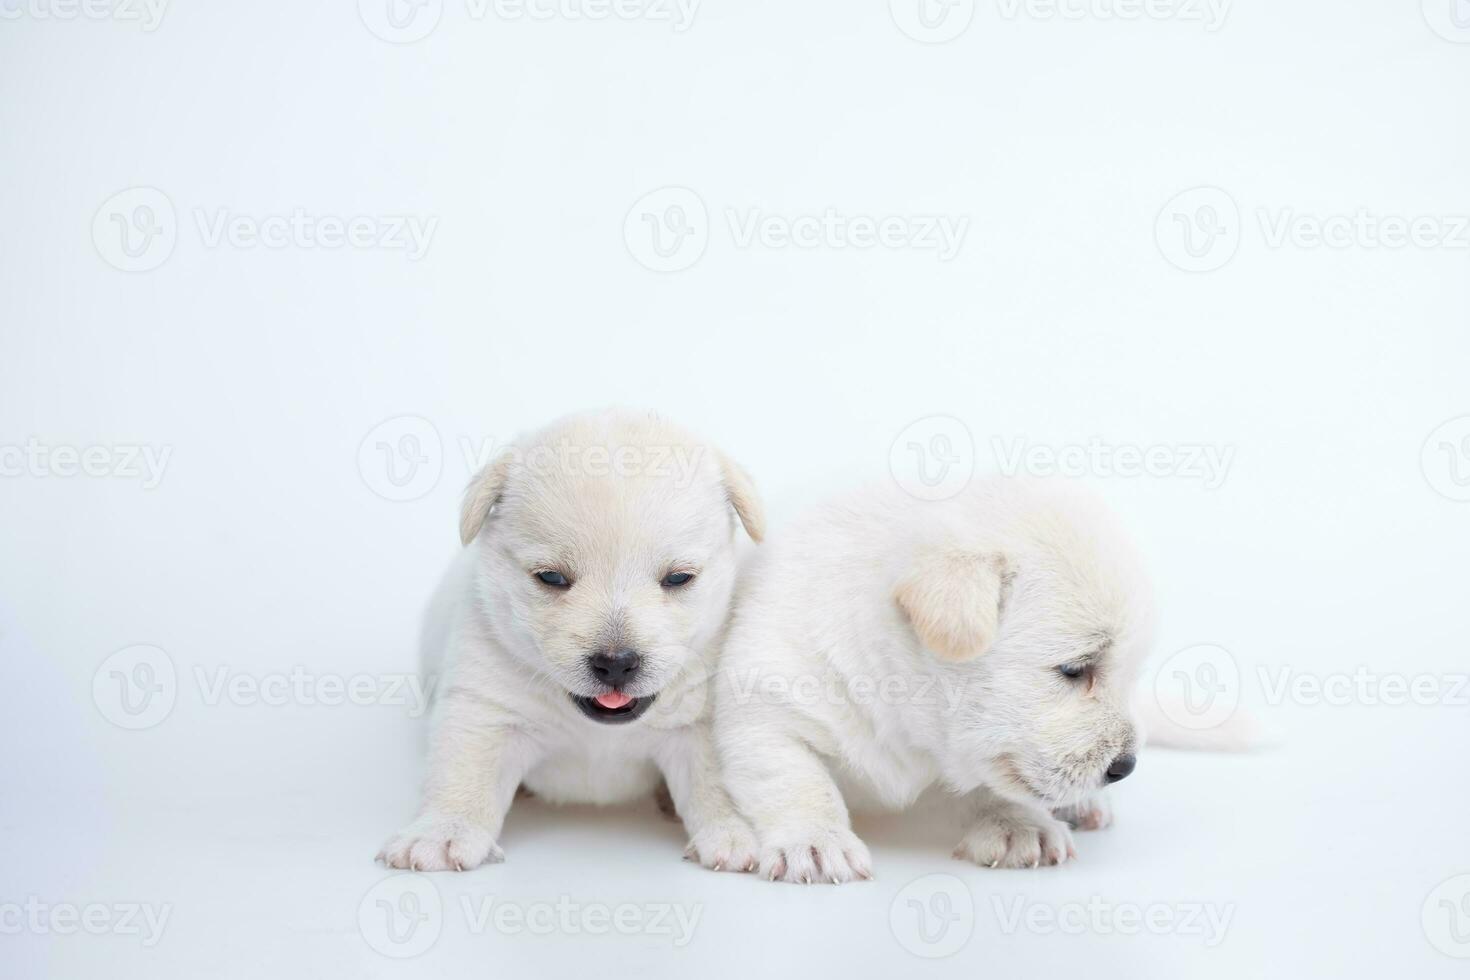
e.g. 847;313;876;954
895;490;1151;807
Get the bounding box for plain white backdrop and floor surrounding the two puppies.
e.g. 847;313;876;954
0;0;1470;979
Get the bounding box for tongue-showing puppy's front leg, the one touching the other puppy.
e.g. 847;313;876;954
654;724;757;871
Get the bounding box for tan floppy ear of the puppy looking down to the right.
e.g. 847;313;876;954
894;550;1010;660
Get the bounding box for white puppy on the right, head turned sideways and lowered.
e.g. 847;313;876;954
716;479;1152;882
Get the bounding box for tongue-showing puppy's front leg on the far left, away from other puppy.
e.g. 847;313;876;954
378;692;535;871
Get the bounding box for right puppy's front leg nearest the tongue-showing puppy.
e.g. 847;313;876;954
723;732;873;884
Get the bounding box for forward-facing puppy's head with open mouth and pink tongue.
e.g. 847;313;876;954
460;411;763;723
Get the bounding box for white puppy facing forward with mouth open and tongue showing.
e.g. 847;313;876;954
378;411;763;871
